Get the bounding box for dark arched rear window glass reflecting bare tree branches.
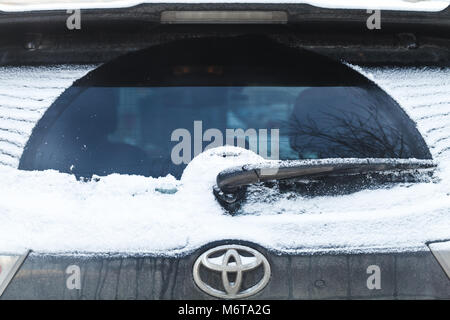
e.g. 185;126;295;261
21;37;431;178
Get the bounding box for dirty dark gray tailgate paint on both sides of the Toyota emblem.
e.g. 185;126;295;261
1;242;450;300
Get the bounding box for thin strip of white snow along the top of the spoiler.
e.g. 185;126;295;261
0;0;449;12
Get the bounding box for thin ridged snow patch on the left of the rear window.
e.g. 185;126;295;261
0;65;94;167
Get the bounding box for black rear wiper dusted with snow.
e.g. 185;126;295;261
217;158;436;193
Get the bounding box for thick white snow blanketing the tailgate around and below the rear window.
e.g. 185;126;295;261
0;67;450;256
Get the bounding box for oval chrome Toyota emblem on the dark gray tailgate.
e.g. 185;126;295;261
194;245;270;299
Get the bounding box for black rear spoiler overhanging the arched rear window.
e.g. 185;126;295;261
0;0;450;66
